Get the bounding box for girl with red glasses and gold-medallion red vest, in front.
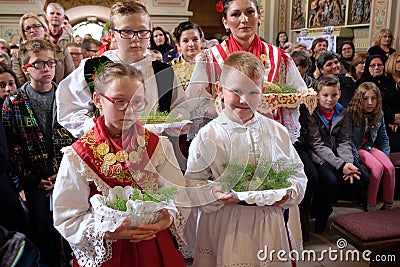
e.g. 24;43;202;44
54;63;186;267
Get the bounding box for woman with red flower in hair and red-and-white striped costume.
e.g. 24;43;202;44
186;0;307;143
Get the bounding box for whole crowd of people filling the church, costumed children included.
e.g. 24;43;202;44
0;0;400;267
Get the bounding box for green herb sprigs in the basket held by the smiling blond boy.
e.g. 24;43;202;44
219;162;296;192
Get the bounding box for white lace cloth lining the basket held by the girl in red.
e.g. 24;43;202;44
90;186;178;232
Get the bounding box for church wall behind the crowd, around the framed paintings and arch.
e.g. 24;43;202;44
0;0;400;51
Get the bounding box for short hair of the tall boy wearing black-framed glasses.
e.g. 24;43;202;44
110;0;150;29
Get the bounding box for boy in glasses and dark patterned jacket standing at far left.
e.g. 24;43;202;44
3;40;74;266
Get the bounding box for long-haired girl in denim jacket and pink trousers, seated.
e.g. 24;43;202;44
349;82;395;211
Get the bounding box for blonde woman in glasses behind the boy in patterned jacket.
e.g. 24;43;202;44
12;13;75;85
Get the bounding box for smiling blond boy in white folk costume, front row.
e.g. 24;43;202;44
185;52;307;266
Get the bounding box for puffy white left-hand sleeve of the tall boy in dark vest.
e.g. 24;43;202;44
56;61;95;138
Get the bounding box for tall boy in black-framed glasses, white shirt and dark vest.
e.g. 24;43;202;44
56;0;185;137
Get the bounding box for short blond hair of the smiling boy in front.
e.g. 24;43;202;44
220;51;265;84
